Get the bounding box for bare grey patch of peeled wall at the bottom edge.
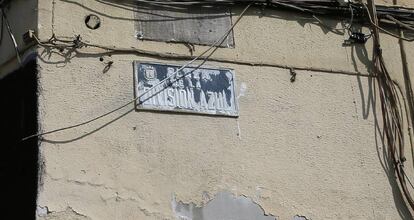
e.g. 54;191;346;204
171;192;276;220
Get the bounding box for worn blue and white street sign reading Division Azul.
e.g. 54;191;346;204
134;61;238;117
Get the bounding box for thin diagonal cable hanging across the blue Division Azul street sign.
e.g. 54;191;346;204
22;4;251;141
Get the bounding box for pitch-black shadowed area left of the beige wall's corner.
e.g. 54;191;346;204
0;61;38;220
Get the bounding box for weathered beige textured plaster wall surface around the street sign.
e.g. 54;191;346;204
34;0;413;219
